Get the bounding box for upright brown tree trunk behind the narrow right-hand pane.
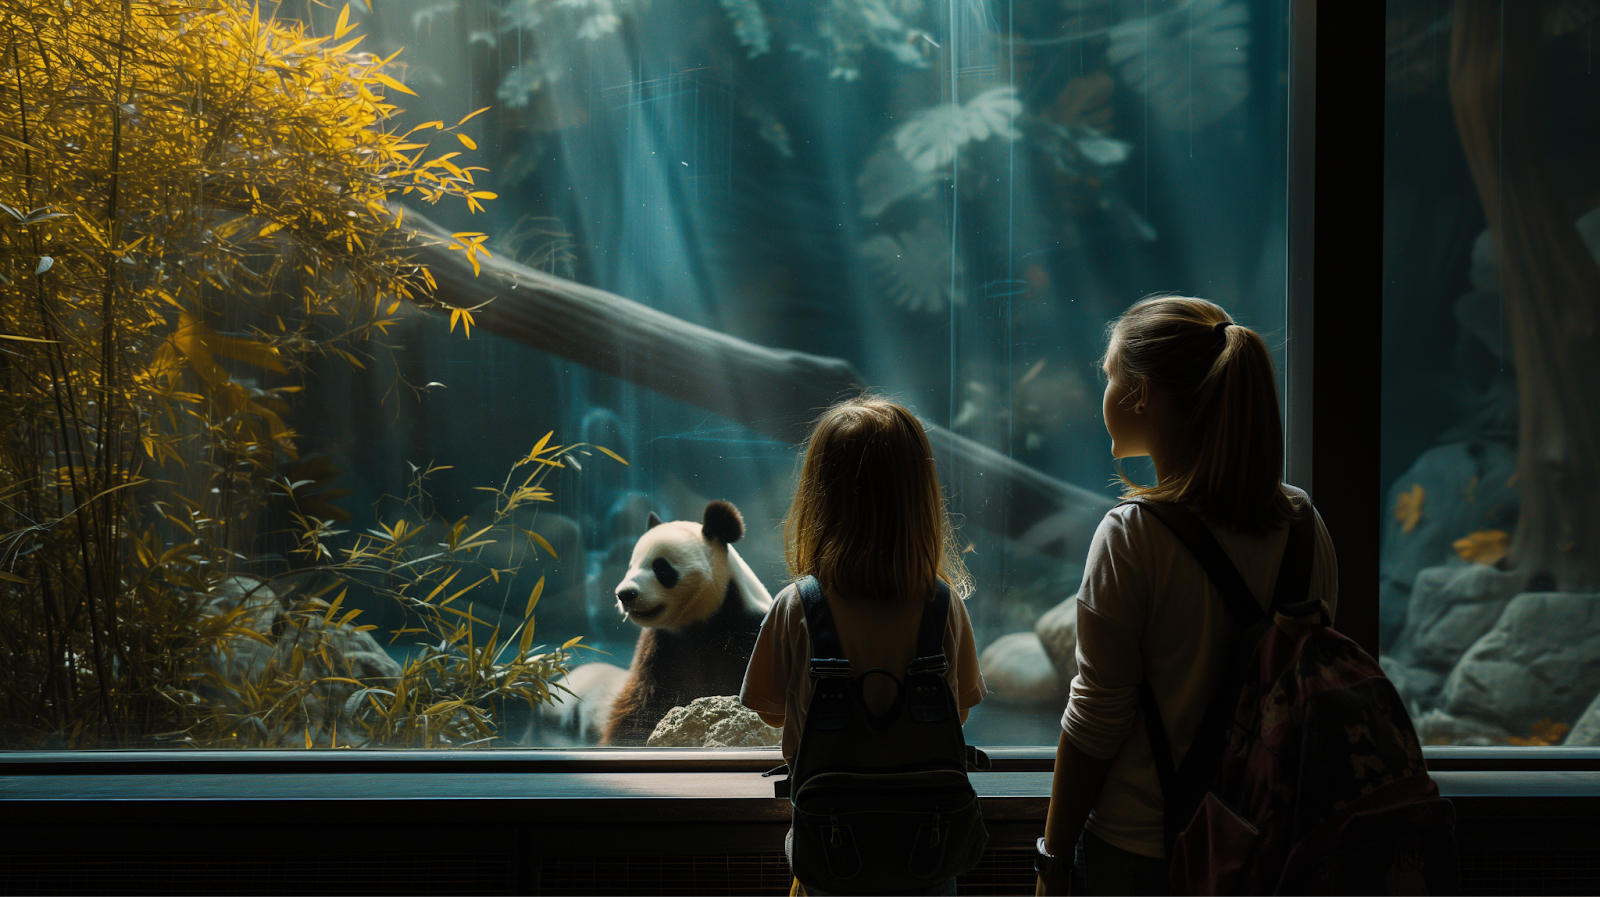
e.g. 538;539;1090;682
1450;0;1600;592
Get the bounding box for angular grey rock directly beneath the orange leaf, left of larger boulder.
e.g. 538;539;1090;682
1390;561;1526;673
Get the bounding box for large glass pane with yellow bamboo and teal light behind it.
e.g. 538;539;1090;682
0;0;1288;748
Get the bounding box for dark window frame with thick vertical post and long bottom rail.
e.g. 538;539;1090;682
0;0;1600;780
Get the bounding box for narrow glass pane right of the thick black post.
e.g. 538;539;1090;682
1381;2;1600;745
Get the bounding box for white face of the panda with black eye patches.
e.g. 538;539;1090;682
616;520;730;630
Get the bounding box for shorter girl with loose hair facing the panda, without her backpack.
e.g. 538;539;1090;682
739;395;986;895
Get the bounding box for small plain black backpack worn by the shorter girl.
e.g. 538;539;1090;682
778;576;989;892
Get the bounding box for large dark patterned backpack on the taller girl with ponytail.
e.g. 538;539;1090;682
1136;500;1459;897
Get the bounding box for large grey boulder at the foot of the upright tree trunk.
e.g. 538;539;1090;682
1442;592;1600;736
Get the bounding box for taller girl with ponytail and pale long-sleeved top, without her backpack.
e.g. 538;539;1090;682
1037;296;1338;897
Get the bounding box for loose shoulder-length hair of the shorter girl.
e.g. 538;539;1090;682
784;395;971;603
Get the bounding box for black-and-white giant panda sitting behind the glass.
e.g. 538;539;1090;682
602;500;773;745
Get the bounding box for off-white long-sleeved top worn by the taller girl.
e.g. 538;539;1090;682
1061;492;1339;857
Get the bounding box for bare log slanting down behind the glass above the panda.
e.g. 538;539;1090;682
396;208;1112;560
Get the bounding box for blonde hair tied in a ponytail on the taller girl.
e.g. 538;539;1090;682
1106;296;1299;534
